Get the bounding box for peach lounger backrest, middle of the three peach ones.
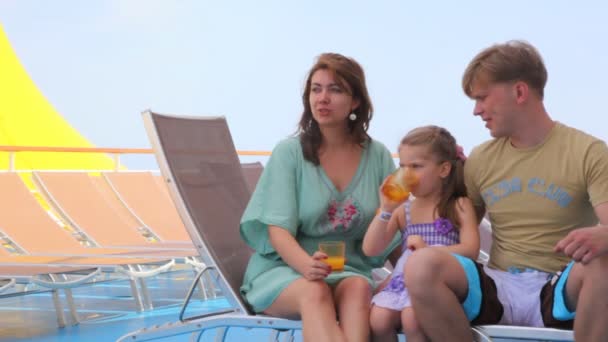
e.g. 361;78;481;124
33;172;196;254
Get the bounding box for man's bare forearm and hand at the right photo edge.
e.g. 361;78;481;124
554;202;608;264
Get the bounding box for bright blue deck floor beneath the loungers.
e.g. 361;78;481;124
0;270;301;342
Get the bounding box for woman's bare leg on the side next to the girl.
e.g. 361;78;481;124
334;276;372;342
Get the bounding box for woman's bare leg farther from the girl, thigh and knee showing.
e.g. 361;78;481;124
264;278;344;342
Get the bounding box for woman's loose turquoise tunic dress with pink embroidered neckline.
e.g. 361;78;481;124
240;138;400;312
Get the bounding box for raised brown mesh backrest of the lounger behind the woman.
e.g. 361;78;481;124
143;112;252;312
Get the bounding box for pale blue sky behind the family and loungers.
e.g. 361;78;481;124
0;0;608;169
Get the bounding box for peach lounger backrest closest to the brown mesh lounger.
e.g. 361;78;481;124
103;172;192;245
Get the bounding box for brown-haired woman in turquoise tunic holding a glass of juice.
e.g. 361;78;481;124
241;53;398;342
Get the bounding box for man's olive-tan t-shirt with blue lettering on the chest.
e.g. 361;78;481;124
465;122;608;272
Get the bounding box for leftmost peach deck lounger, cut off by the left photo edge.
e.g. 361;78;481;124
0;172;190;322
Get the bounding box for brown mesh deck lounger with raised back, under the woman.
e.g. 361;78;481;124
119;112;502;341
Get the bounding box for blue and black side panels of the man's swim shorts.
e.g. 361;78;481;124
453;254;575;329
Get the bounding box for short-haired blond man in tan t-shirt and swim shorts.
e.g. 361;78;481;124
405;41;608;341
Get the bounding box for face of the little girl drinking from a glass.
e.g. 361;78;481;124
399;145;451;198
